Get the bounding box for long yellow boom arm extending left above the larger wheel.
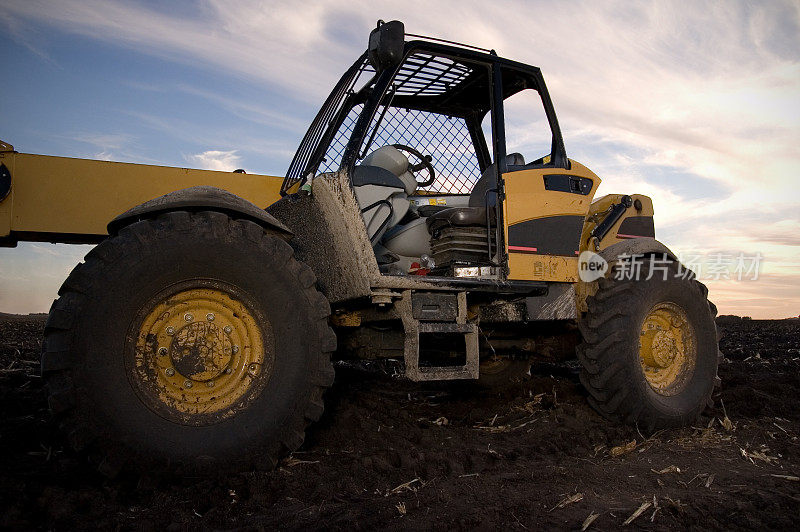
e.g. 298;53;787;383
0;152;283;240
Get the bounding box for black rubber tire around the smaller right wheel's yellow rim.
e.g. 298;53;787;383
577;263;721;433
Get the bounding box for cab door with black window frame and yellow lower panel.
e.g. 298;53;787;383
492;59;600;282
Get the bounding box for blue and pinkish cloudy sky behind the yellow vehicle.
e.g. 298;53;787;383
0;0;800;317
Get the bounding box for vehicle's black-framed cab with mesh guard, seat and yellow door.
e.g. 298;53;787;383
281;22;600;281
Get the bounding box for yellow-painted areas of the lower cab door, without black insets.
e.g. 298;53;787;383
503;161;600;283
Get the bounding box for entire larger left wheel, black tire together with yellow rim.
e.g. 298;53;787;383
42;212;336;475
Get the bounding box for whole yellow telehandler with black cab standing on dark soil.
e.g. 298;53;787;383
0;21;719;474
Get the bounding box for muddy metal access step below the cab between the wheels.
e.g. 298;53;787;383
395;290;479;381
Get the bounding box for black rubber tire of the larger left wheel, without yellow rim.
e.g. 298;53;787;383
42;212;336;475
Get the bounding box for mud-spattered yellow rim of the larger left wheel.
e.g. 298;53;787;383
127;281;274;425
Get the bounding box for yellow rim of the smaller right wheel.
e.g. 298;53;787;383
639;302;697;395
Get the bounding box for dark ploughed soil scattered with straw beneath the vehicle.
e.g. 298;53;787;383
0;316;800;530
